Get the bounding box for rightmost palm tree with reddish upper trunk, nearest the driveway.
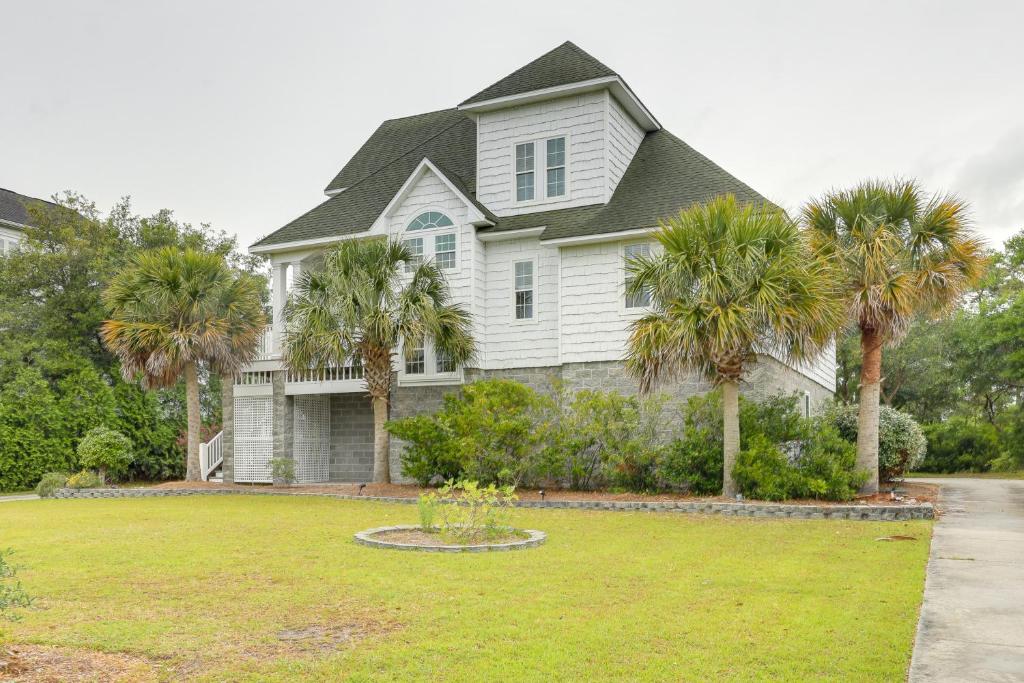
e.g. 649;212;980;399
803;180;984;494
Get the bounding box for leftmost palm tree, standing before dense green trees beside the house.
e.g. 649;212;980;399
100;247;266;481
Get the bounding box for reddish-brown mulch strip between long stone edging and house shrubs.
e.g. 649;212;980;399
156;481;938;506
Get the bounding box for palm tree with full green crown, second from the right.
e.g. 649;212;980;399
627;195;840;497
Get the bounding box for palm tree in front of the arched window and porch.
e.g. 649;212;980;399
284;239;475;483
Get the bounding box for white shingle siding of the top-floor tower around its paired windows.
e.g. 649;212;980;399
476;92;607;216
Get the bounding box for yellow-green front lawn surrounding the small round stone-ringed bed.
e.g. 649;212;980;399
0;496;931;681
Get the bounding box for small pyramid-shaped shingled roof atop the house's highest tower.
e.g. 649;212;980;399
462;41;618;104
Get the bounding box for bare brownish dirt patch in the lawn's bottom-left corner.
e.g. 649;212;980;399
0;645;160;683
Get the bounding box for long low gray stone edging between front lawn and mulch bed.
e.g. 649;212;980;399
53;488;935;521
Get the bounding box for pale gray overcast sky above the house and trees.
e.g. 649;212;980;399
0;0;1024;250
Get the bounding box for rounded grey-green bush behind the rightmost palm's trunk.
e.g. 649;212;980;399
825;403;928;481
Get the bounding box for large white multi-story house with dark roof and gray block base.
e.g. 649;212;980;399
214;42;835;482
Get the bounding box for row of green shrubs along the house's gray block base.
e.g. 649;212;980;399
387;380;924;500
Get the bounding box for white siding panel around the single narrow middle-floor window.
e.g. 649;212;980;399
483;238;558;369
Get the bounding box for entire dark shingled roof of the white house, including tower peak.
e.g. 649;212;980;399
253;42;767;248
